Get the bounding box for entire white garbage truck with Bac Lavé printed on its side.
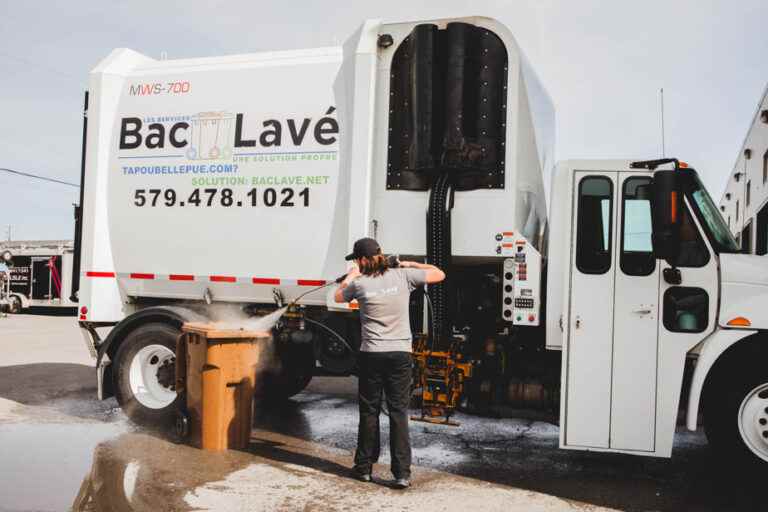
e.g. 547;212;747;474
74;17;768;467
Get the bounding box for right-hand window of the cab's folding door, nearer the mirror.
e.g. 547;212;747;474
619;177;656;276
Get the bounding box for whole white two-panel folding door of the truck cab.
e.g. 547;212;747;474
564;172;659;452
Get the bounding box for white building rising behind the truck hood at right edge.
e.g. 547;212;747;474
720;83;768;254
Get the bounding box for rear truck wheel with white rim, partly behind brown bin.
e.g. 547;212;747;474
113;323;180;426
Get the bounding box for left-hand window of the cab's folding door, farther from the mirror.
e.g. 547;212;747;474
576;176;613;274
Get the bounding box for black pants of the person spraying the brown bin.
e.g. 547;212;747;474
355;352;412;478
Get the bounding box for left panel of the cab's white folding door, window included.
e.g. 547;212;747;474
565;172;618;448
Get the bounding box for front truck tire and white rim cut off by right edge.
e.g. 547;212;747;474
703;350;768;473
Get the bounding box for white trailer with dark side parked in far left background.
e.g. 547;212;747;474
0;240;77;313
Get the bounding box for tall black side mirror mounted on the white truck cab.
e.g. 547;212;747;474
651;171;683;267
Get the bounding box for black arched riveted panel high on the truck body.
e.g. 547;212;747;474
387;23;508;191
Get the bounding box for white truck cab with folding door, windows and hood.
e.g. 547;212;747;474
547;159;768;468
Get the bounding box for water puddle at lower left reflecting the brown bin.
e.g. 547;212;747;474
0;421;260;512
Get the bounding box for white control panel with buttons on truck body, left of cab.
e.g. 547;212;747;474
501;238;541;326
